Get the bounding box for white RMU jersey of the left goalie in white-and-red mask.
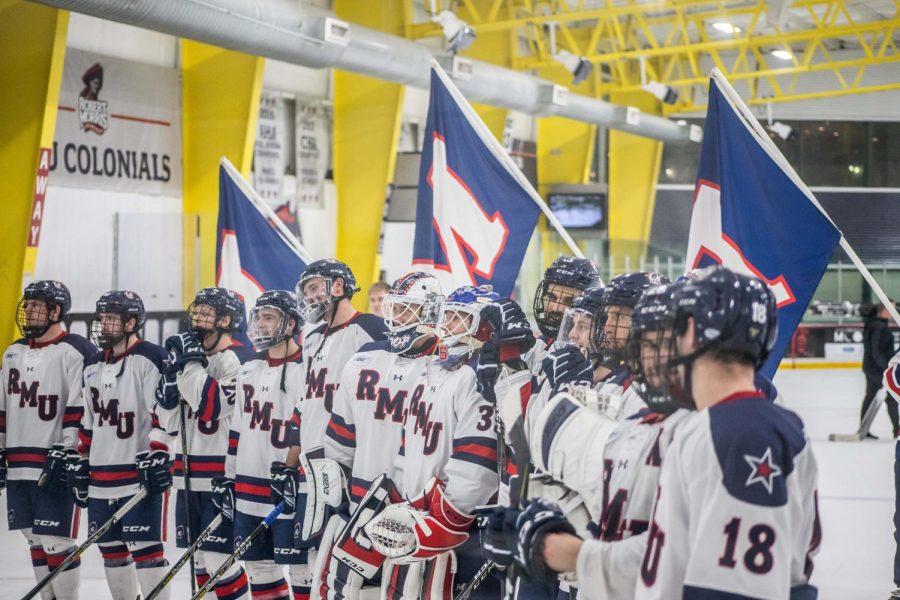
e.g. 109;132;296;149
325;340;431;511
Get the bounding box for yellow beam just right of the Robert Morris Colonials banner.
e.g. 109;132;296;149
181;40;264;306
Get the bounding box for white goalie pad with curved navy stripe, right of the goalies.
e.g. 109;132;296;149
529;393;616;495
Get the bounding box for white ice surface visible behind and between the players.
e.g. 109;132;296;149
0;370;894;600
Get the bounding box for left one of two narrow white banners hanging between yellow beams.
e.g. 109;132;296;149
253;90;287;203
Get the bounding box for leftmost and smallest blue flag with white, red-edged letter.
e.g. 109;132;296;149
216;159;306;324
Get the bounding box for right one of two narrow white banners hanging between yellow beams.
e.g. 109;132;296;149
295;102;331;208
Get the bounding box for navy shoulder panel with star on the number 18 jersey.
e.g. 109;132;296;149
708;393;807;506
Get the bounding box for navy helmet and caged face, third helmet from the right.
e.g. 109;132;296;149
594;273;669;371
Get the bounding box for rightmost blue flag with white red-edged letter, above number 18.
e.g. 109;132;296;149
687;78;841;377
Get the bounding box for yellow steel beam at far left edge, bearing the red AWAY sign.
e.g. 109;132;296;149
0;0;69;346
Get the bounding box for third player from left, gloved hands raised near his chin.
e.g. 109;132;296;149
156;288;253;600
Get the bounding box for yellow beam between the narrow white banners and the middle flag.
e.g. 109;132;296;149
333;0;404;310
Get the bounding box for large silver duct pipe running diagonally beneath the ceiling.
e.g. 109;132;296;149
32;0;699;144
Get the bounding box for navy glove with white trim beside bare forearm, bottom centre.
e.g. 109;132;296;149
514;500;577;582
